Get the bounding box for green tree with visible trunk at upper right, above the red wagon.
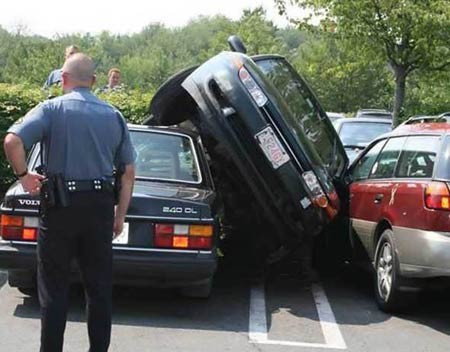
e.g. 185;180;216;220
274;0;450;124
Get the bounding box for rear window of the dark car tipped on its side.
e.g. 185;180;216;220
256;58;345;176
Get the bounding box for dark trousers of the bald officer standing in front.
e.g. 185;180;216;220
37;191;114;352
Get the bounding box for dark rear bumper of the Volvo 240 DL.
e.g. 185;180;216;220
0;241;217;287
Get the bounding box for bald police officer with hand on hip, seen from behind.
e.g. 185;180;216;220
4;53;135;352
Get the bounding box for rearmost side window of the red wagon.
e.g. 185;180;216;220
396;136;439;178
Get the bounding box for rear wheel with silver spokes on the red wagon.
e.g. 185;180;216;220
374;229;408;313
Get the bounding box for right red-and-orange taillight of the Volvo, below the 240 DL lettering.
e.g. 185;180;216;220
154;224;214;249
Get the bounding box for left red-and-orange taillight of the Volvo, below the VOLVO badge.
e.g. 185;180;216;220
0;215;39;241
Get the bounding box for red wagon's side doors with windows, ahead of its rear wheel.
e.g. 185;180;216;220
349;137;406;258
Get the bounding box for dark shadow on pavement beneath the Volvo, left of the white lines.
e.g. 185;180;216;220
14;266;253;332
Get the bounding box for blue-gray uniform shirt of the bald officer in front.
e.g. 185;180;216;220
8;88;136;180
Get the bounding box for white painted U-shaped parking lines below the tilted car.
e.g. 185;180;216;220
249;284;347;350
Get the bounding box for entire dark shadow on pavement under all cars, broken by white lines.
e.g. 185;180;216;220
9;258;450;335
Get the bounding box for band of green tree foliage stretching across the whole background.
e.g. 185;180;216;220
0;5;450;119
